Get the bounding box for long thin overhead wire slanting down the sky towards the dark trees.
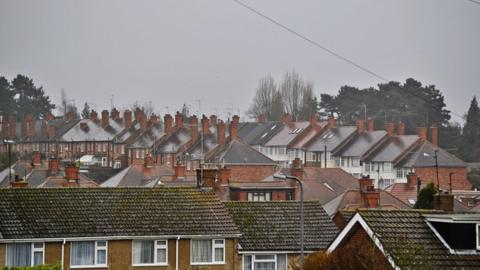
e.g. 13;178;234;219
233;0;389;82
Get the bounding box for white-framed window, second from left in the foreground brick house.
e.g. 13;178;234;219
70;241;107;266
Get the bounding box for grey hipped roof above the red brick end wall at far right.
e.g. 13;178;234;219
398;141;467;168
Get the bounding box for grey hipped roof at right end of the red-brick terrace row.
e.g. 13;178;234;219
206;139;276;165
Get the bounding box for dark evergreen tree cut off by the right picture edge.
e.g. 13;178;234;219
459;97;480;162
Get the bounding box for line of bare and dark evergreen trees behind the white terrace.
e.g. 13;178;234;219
249;71;480;161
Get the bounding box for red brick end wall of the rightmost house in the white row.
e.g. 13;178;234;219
415;167;472;190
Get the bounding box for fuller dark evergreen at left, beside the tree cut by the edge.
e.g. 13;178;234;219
12;74;55;118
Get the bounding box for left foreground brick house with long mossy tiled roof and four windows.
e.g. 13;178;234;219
0;188;240;270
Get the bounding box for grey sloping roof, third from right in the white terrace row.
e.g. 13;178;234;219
334;130;387;157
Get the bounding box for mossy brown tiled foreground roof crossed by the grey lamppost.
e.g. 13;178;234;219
224;201;338;253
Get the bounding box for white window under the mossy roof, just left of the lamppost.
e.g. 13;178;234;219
243;254;287;270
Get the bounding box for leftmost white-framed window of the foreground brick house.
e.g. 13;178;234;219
6;243;45;267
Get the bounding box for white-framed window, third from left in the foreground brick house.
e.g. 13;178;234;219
132;240;168;266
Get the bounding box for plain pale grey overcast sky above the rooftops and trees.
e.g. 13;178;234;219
0;0;480;120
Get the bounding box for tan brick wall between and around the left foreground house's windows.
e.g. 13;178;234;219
0;238;236;270
